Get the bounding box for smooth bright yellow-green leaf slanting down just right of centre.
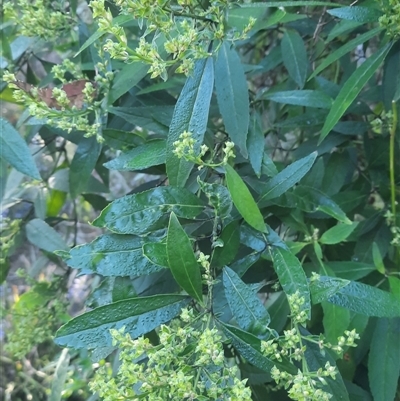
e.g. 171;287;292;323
225;165;267;232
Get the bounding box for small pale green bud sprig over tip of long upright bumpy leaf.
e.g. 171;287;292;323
173;131;235;170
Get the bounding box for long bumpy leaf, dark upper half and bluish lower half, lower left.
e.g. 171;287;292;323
54;294;187;349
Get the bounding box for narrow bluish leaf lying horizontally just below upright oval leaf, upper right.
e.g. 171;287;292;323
261;89;333;109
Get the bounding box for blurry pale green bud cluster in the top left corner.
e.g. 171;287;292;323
4;0;76;40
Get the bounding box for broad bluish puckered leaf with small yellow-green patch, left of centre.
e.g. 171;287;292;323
66;234;162;277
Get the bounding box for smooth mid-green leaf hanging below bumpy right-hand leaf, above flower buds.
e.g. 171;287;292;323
322;301;350;344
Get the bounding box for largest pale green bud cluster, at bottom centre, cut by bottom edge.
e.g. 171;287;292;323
90;309;251;401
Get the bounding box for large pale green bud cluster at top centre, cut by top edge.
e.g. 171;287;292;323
90;0;255;80
